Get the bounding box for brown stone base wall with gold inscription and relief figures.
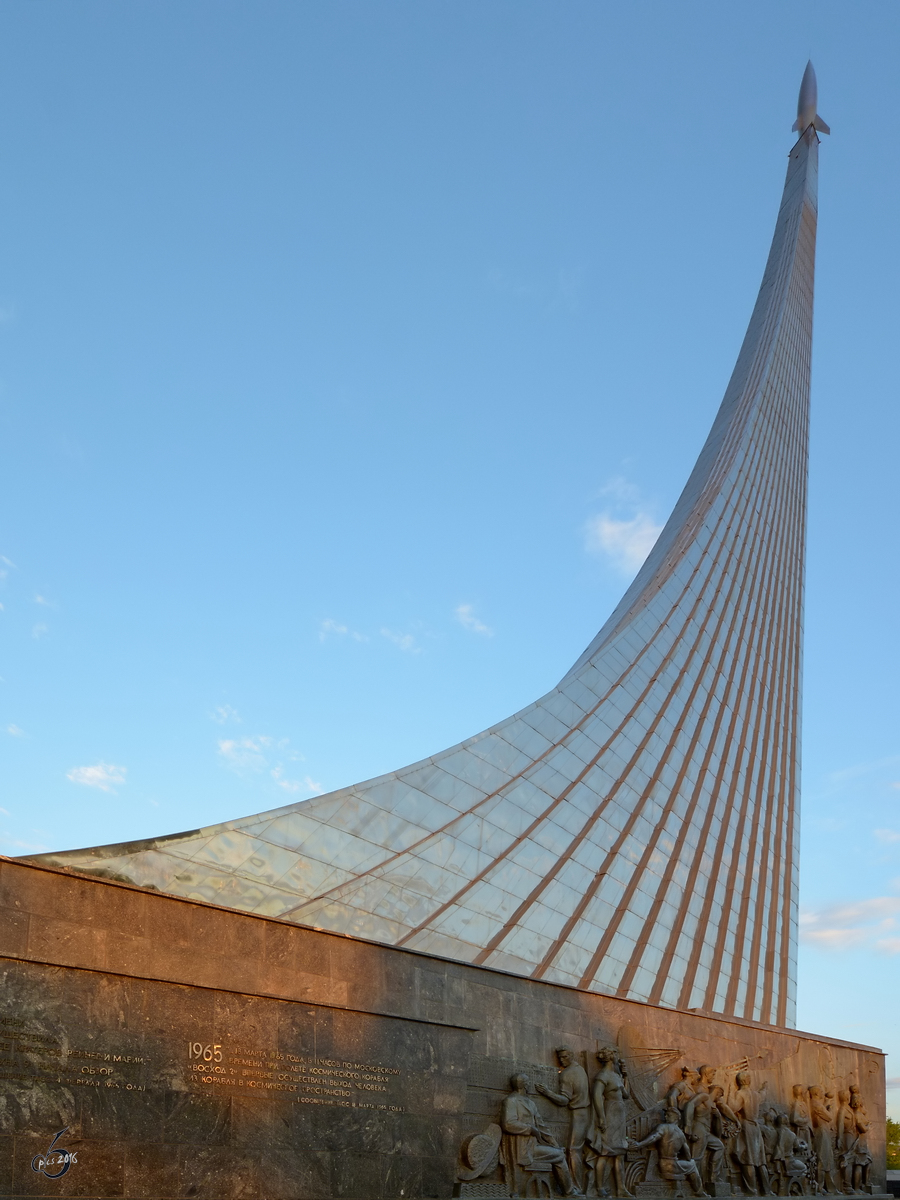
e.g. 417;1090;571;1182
0;859;886;1200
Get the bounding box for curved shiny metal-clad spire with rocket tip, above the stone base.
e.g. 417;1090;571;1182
31;77;821;1025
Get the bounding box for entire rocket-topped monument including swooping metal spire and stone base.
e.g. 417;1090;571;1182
0;65;884;1200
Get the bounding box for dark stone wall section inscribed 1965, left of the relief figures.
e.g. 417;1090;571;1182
0;962;470;1200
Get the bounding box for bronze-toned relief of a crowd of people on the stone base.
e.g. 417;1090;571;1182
456;1043;872;1200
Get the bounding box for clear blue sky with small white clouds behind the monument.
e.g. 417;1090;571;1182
0;0;900;1115
